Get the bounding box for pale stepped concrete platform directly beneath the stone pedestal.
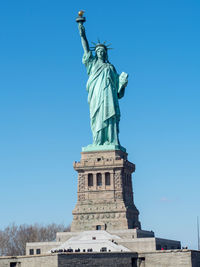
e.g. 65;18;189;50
26;229;181;255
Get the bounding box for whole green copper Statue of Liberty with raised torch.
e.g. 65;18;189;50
76;12;128;151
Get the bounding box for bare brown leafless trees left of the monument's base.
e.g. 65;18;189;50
0;223;70;256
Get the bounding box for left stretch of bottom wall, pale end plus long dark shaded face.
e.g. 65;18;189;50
0;253;137;267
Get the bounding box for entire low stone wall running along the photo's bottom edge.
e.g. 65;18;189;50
0;250;200;267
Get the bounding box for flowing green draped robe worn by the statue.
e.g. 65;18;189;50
83;51;124;145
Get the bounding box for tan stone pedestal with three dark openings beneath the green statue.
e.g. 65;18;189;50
71;150;140;232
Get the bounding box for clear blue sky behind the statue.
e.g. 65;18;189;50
0;0;200;251
